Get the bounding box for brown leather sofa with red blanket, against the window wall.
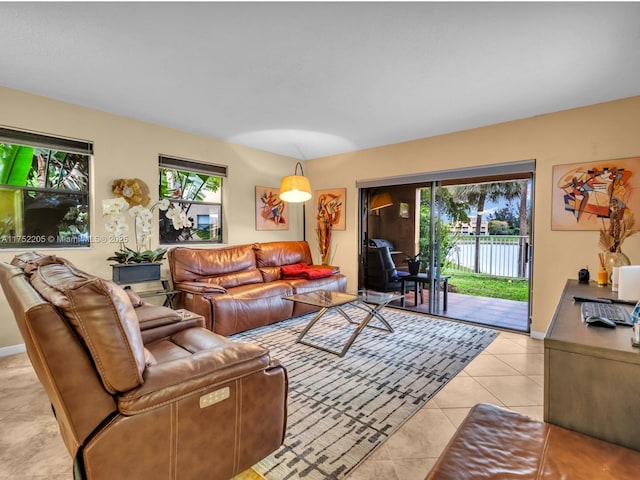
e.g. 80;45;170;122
168;241;347;335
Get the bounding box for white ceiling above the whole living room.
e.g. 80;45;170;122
0;2;640;159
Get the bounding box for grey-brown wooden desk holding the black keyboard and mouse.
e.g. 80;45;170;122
544;280;640;450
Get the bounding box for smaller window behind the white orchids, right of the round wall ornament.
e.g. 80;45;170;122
158;155;227;244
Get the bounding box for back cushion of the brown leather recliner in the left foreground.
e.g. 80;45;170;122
31;262;145;393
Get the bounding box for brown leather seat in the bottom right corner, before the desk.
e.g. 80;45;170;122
427;404;640;480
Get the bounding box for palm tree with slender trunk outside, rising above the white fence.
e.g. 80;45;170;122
452;182;521;273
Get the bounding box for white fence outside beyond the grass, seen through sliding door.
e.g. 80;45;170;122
446;235;529;278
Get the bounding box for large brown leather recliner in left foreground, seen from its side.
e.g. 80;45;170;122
0;255;287;480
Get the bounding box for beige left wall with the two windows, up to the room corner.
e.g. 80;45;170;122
0;88;302;352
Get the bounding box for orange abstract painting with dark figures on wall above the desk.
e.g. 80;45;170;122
551;157;640;230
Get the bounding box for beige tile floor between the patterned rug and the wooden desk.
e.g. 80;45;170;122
347;332;544;480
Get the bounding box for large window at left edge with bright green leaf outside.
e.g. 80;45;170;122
0;127;93;248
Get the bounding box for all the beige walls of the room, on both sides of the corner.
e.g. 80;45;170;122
0;88;640;349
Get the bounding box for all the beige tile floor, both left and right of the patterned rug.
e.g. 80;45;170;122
0;332;544;480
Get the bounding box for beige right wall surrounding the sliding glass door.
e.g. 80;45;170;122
305;97;640;334
